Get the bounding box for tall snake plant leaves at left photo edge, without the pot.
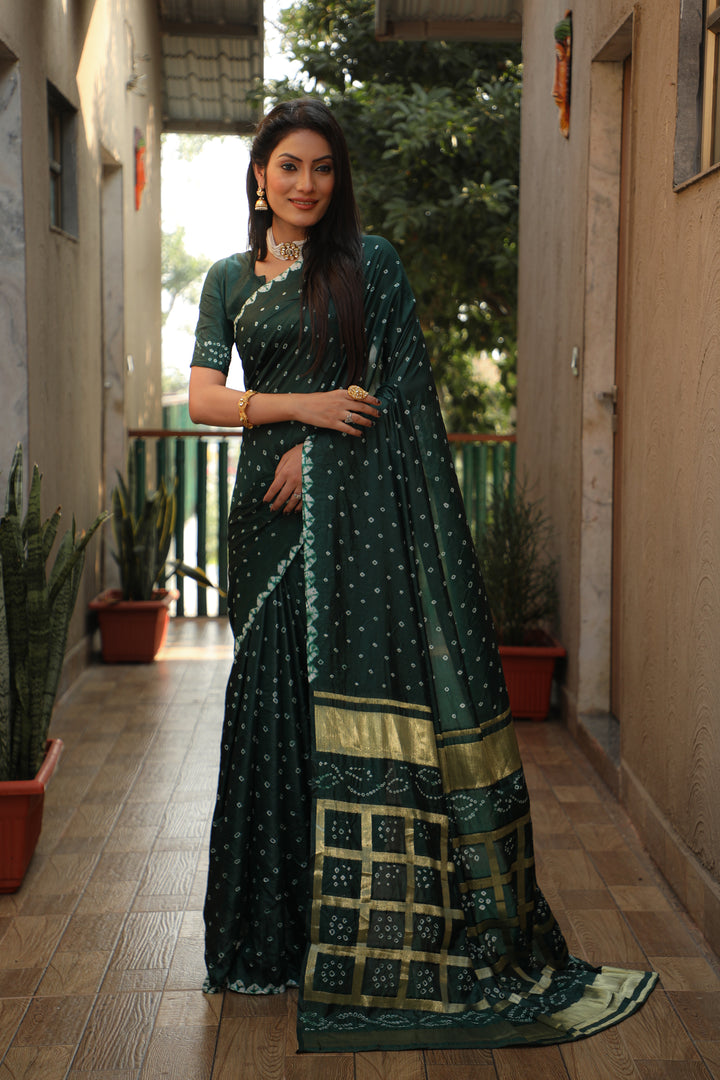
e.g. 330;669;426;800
0;445;108;780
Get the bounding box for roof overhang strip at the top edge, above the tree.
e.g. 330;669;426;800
375;0;522;41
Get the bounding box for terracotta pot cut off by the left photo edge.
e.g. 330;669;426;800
0;739;63;892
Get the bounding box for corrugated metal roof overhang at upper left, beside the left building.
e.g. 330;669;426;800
158;0;263;133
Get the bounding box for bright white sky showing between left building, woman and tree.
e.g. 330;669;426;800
161;0;297;387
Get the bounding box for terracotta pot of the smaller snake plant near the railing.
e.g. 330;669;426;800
90;589;179;664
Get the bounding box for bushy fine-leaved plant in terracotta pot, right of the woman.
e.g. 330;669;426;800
477;484;566;720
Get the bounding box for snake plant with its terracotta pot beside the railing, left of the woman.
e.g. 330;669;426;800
90;467;221;663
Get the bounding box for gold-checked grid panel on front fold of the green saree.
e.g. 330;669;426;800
304;800;483;1011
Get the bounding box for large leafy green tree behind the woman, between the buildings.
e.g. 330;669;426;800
266;0;521;431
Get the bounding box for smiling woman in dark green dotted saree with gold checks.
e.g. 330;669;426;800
190;99;654;1051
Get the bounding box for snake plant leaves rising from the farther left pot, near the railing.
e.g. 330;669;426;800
112;467;225;600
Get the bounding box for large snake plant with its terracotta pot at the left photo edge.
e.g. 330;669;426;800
0;445;107;892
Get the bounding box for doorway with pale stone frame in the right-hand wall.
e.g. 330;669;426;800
575;15;634;734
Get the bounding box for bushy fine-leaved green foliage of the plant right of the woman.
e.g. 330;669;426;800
477;484;558;645
